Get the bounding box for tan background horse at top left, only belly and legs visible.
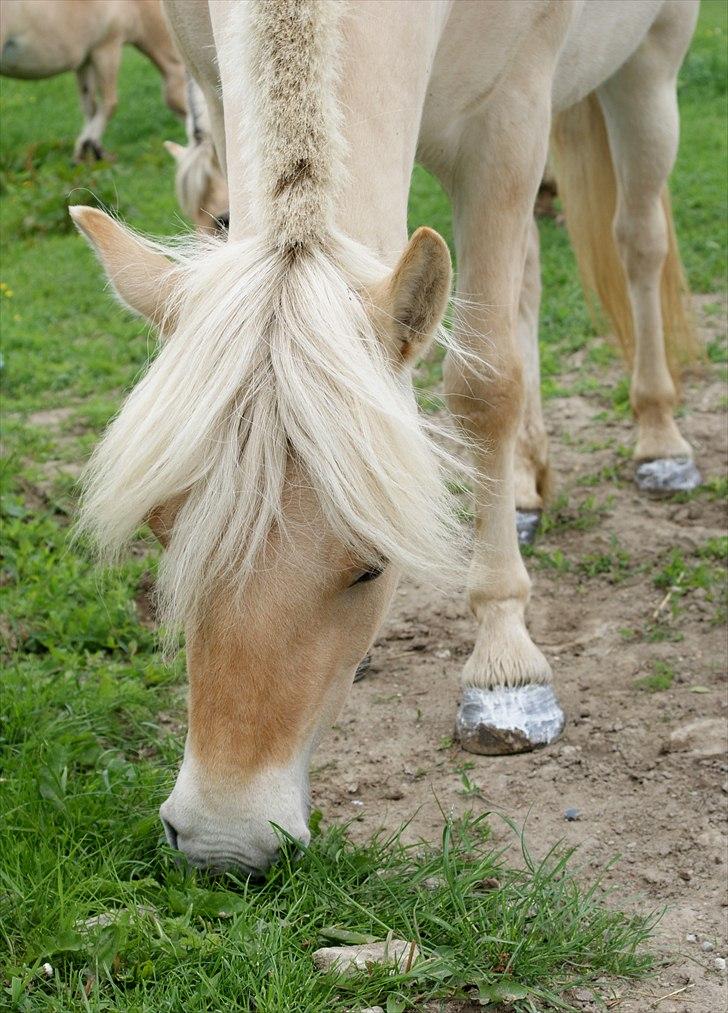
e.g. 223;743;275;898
0;0;186;161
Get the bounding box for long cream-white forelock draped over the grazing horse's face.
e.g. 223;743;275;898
80;236;462;634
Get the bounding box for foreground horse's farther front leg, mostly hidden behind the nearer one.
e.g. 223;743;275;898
515;219;549;545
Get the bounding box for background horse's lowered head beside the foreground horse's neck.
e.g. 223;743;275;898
164;77;230;234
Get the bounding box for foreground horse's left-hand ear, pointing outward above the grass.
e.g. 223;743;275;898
68;206;180;331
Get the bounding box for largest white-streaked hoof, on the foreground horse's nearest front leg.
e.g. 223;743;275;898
455;683;564;756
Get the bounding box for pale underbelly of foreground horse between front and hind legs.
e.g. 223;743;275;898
553;0;664;112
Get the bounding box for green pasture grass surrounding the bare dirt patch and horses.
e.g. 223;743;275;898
0;3;727;1013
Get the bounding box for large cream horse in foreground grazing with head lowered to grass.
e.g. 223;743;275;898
71;0;697;870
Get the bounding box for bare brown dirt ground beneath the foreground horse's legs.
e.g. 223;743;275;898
312;301;728;1013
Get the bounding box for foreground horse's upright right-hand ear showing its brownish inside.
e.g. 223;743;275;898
370;228;453;365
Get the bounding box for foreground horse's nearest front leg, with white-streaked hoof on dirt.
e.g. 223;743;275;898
444;98;564;754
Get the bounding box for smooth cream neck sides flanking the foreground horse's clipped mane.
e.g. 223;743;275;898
211;0;450;263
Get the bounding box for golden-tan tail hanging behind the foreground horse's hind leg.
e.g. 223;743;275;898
552;92;700;385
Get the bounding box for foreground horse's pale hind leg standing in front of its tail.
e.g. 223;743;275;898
597;4;701;490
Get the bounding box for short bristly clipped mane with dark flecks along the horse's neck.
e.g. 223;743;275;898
248;0;344;250
